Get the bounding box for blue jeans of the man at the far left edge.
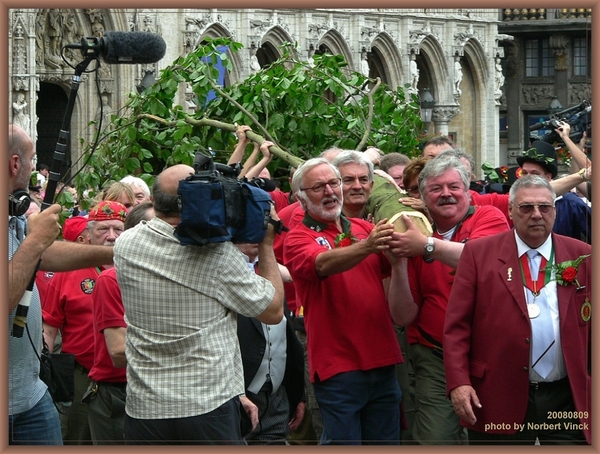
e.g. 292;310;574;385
8;391;63;445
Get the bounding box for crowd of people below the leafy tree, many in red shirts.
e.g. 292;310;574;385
8;119;592;445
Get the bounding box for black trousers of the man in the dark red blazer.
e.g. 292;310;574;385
469;378;591;445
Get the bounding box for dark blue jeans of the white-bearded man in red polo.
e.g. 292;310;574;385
314;366;402;445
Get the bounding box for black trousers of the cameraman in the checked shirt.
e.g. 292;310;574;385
125;396;246;445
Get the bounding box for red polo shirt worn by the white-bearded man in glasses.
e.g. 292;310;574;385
284;216;403;382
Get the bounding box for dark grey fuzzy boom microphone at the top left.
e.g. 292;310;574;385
65;31;167;65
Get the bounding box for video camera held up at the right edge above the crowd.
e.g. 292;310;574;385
529;100;592;143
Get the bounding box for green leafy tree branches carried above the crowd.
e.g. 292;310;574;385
76;38;422;190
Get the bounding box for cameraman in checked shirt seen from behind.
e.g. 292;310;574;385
115;165;283;444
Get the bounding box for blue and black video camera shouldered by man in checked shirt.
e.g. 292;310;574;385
175;153;282;246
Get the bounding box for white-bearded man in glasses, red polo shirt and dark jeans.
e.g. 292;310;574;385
284;158;408;444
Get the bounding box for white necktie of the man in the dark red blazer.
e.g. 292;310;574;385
527;249;555;378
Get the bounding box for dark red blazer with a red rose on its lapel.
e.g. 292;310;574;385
443;230;592;442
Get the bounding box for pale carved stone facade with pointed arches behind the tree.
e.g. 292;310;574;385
9;9;512;177
